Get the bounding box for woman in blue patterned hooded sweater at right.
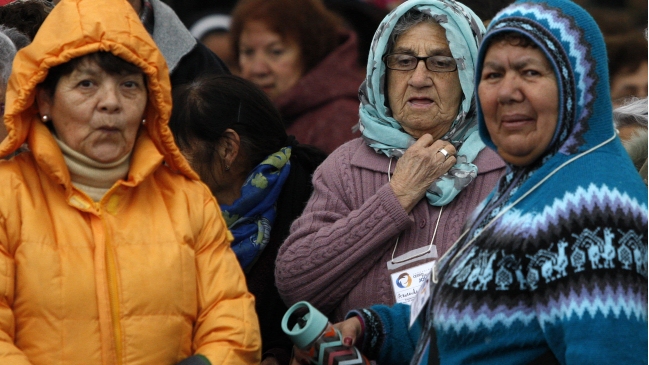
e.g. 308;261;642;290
330;0;648;365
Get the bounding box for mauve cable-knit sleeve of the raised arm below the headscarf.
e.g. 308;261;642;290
275;144;411;313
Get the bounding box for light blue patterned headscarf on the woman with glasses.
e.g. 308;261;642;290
359;0;485;206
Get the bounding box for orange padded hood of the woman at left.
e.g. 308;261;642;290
0;0;198;182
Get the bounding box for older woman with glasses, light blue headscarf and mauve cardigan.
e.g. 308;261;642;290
276;0;504;324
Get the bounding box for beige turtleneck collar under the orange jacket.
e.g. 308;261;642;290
53;135;131;202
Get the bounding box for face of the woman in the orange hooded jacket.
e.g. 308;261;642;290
38;59;147;163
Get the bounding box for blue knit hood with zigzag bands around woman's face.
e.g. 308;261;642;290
475;0;621;158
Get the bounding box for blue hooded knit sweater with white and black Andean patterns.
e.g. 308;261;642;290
420;0;647;365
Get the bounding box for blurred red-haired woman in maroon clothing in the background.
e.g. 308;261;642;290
230;0;363;153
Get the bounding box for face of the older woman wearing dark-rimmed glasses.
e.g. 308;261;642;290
387;23;462;139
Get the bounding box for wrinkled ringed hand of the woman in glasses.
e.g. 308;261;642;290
390;134;456;213
